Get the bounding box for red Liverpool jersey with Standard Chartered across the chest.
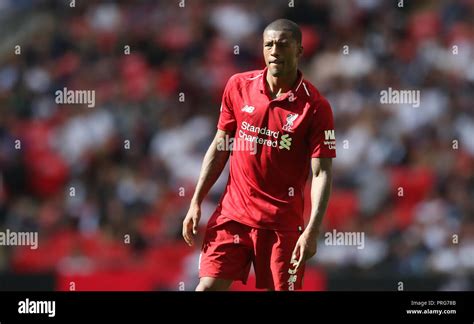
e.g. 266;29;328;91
217;68;336;231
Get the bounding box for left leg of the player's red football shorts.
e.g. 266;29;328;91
199;215;253;283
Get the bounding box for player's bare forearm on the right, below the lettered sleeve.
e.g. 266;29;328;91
306;171;332;235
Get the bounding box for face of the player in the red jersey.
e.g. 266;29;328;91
263;29;303;77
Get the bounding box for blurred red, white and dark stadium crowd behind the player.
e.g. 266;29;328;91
0;0;474;290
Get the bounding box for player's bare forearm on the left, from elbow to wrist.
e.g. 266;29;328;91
192;136;230;204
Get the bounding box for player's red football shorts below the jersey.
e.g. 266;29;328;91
199;213;304;290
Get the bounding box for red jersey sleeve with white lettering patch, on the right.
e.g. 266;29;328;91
310;98;336;158
